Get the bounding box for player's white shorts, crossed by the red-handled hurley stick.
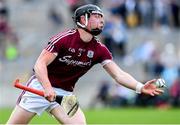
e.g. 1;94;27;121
17;76;72;115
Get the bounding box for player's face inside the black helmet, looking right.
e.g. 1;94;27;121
87;13;104;30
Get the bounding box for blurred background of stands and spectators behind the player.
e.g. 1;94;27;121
0;0;180;123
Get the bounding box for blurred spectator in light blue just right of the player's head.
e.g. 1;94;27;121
103;14;127;58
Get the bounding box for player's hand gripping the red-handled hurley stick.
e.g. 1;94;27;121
44;87;56;102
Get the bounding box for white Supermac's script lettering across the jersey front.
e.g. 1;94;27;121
59;56;91;67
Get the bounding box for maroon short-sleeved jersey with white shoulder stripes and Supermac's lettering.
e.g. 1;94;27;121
45;29;112;91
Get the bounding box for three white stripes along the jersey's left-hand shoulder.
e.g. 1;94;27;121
46;30;76;52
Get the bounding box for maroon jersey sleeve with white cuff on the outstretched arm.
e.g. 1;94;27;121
99;44;113;66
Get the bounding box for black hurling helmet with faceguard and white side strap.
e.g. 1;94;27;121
73;4;104;36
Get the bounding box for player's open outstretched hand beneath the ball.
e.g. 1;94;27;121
141;79;164;96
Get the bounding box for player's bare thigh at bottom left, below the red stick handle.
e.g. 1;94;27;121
7;105;35;124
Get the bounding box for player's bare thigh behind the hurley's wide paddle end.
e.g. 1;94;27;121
51;106;86;124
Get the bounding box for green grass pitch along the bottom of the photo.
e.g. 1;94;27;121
0;107;180;124
